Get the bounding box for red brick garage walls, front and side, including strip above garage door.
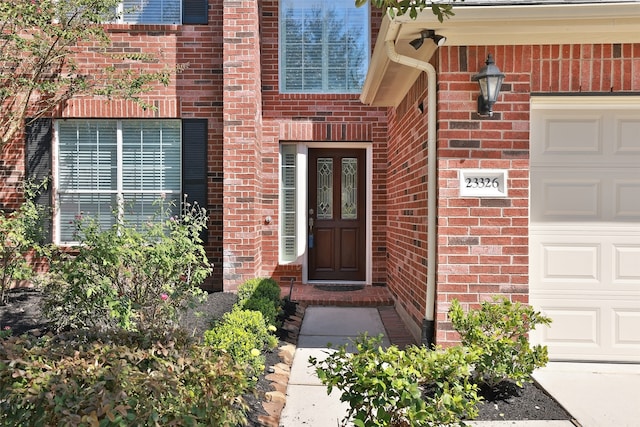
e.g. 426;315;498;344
387;45;640;344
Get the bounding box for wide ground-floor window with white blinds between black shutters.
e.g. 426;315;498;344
55;119;182;242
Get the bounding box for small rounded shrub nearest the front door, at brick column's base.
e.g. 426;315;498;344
237;278;282;326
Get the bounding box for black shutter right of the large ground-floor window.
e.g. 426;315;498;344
182;119;208;243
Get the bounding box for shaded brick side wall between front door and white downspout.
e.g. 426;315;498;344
386;86;429;338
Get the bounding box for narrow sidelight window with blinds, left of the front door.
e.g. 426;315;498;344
280;145;297;262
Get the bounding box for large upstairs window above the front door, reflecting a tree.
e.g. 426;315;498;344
280;0;370;93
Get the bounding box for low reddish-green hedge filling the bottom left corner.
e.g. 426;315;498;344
0;332;248;427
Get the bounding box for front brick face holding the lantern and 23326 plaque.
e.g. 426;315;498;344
436;47;531;342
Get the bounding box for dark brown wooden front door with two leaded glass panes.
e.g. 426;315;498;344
308;149;366;281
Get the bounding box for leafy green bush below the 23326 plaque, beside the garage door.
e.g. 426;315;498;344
449;297;551;386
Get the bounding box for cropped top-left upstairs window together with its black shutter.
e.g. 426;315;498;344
113;0;209;24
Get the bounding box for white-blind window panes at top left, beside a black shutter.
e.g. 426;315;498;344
122;0;182;24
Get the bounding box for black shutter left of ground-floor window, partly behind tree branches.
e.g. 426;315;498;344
25;118;53;242
